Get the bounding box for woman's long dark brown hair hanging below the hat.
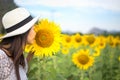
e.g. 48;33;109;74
0;30;30;80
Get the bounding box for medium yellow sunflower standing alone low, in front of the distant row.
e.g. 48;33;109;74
72;50;94;70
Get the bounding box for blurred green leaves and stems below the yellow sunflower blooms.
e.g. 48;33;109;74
28;35;120;80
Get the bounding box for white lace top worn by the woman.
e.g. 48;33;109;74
0;49;28;80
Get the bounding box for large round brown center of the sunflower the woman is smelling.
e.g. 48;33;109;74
35;30;54;48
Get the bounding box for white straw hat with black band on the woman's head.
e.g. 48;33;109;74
0;8;39;39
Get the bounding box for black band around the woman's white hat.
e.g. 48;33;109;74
6;16;33;33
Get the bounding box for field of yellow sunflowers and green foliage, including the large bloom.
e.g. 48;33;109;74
23;19;120;80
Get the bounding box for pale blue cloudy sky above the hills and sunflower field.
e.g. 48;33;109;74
14;0;120;33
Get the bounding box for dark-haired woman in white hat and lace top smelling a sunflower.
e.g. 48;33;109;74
0;8;39;80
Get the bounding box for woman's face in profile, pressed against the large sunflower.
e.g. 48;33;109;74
27;26;36;44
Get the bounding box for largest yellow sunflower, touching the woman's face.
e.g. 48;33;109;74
26;19;61;57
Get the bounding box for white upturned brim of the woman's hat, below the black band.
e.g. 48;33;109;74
0;16;39;39
